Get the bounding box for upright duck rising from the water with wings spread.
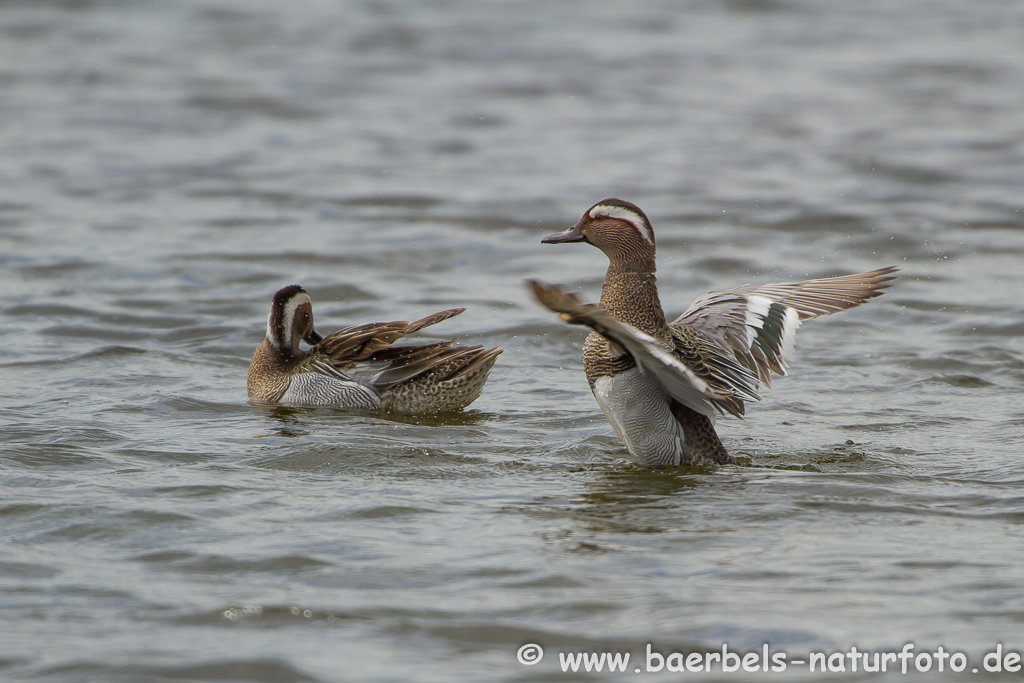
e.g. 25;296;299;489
528;198;898;467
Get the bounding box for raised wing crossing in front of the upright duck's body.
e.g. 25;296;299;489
528;281;760;417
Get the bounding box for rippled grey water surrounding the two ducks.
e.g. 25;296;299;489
0;0;1024;682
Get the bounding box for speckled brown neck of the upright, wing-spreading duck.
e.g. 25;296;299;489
601;259;669;341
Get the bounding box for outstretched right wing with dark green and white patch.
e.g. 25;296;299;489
670;266;898;387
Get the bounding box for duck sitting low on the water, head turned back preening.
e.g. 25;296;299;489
247;285;502;413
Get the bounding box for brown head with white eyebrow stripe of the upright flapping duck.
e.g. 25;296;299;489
541;199;654;271
